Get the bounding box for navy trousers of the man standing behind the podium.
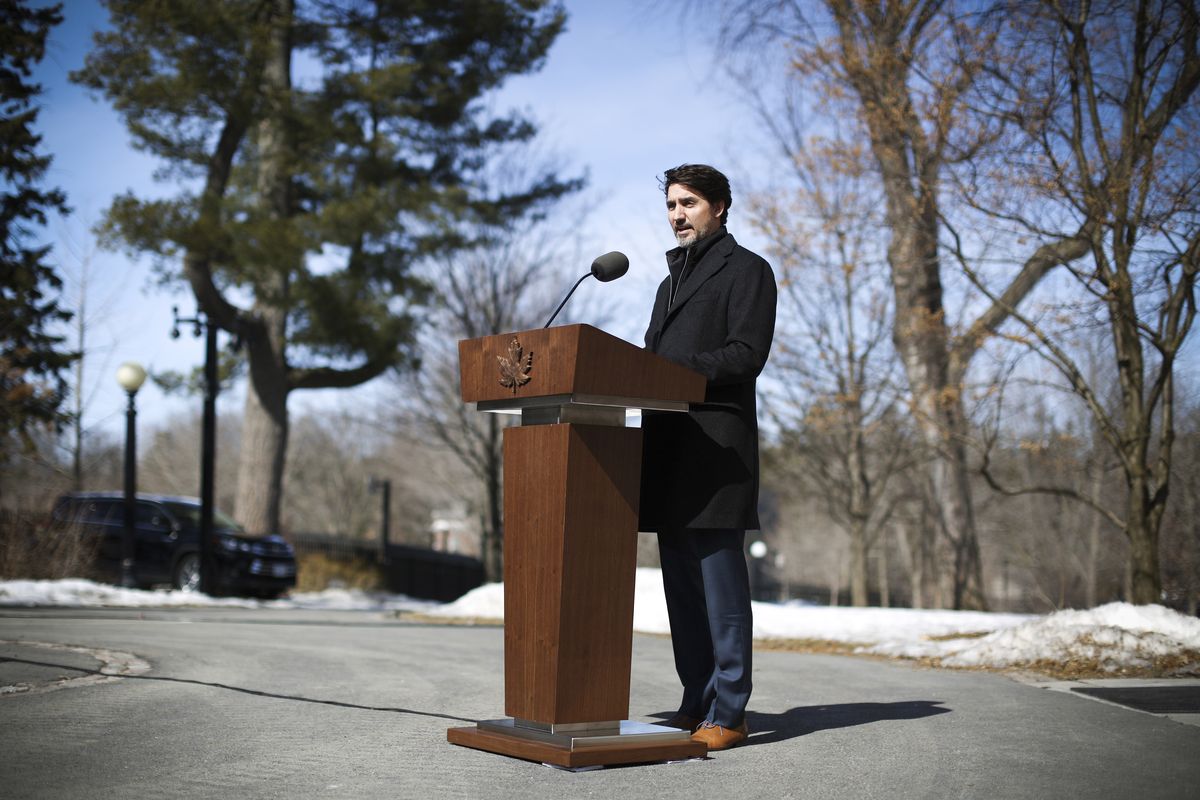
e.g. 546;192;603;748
659;530;754;728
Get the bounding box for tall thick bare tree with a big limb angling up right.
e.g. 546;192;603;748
700;0;1104;608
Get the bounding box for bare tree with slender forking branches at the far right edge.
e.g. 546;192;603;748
953;0;1200;603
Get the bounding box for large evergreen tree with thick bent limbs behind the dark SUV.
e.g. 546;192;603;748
73;0;578;531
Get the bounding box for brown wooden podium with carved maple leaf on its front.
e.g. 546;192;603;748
446;325;706;768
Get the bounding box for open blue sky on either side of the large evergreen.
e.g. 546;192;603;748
35;0;772;435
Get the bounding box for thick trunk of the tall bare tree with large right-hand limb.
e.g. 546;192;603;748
827;0;986;609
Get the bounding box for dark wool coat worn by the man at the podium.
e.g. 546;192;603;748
638;228;776;531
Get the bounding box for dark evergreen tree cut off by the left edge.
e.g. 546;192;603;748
0;0;74;470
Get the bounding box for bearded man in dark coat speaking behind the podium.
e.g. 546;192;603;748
638;164;775;750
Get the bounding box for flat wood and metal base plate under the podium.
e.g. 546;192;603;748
446;720;708;768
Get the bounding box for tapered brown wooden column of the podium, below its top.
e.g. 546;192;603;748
504;425;642;723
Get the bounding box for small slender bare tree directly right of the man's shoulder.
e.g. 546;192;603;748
751;122;913;606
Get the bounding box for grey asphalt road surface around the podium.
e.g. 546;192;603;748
0;608;1200;800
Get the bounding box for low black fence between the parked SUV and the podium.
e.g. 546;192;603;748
288;534;484;602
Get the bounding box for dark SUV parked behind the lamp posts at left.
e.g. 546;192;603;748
53;492;296;597
